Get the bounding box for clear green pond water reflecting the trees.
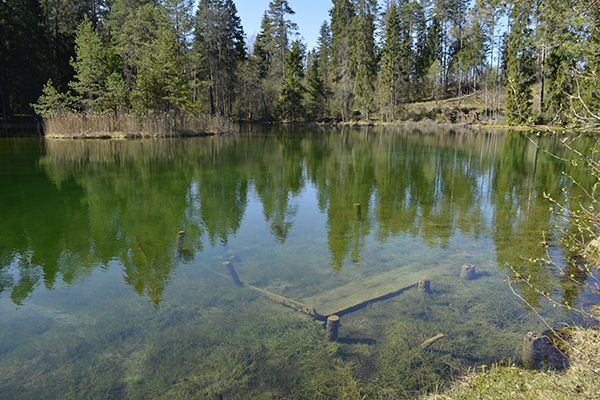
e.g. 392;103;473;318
0;129;591;399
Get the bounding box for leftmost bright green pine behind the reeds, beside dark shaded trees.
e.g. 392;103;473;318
69;18;108;112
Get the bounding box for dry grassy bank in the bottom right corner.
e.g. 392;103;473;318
428;328;600;400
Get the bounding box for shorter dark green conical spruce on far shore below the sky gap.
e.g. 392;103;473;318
277;40;305;121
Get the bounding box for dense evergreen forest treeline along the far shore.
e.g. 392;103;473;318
0;0;600;127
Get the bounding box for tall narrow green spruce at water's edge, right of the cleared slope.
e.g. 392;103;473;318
505;6;533;125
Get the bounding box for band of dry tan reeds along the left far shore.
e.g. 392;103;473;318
44;113;237;139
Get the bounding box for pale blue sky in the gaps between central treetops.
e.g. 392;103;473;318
235;0;332;49
